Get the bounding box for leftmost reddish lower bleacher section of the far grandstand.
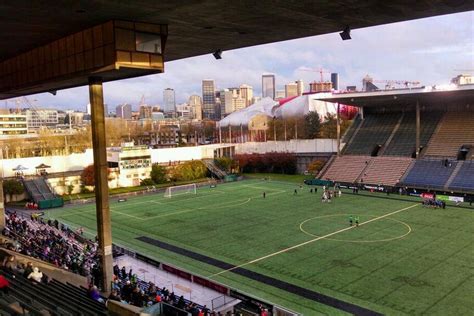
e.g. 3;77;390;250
321;155;372;183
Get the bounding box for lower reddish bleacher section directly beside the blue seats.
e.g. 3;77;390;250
361;157;412;186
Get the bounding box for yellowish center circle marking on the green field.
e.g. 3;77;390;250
300;214;412;243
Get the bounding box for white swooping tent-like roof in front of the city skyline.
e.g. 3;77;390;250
219;93;336;127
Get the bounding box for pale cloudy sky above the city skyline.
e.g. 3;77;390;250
6;11;474;111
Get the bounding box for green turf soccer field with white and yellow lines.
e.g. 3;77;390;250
47;179;474;315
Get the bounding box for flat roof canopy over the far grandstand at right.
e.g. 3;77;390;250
318;84;474;107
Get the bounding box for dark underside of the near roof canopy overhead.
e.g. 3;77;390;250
0;0;474;61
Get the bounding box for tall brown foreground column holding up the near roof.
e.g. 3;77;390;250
89;77;113;293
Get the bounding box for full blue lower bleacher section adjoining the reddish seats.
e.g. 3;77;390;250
402;159;457;189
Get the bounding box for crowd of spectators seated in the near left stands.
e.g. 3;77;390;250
0;212;228;316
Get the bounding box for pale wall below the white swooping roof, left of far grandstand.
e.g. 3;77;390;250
235;139;337;154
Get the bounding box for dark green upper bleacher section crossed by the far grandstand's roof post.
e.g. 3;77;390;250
384;111;443;157
